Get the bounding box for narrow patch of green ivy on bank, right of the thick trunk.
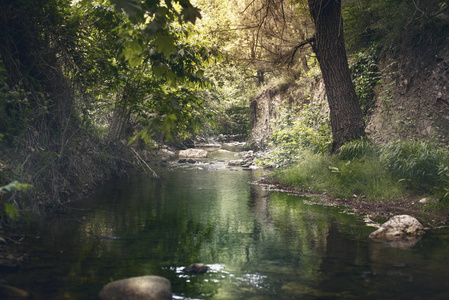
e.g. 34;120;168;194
350;46;380;117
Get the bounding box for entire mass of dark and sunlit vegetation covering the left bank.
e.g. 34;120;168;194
0;0;219;217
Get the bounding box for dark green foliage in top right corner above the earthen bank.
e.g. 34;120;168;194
342;0;449;52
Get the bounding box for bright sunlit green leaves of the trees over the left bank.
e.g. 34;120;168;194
70;1;218;142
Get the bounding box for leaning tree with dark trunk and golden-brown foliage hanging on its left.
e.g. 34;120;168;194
226;0;365;151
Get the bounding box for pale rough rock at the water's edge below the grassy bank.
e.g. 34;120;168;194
369;215;424;240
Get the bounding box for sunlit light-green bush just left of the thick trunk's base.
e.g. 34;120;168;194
263;103;332;167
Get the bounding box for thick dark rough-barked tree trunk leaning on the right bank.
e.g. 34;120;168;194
308;0;365;151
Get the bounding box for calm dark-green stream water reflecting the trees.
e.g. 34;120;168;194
1;151;449;300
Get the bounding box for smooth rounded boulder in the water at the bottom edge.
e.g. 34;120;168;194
98;276;172;300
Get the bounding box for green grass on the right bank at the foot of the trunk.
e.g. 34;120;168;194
273;140;449;202
